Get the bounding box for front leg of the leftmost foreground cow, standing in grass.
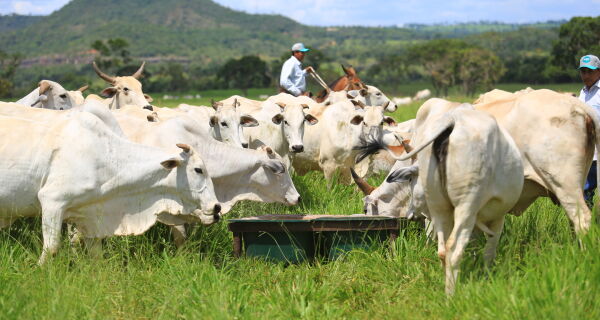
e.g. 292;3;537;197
38;204;64;265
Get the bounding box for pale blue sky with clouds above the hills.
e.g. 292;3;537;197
0;0;600;26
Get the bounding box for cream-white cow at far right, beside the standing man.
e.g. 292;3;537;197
474;89;600;233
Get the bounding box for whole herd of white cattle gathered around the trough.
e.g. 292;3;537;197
0;65;600;293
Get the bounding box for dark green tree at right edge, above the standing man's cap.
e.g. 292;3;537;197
552;16;600;70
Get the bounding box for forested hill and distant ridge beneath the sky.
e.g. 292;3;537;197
0;0;558;64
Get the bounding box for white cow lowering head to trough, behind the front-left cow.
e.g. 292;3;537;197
112;115;300;246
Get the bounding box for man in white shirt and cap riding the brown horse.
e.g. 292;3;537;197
279;43;314;97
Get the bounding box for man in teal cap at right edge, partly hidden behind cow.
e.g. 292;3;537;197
579;54;600;208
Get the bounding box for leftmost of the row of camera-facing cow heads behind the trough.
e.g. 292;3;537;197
209;99;258;148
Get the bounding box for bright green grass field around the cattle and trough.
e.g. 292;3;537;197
0;84;600;319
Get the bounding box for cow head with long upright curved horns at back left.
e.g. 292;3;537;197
92;62;152;110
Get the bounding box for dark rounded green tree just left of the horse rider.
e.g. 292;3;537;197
217;56;271;95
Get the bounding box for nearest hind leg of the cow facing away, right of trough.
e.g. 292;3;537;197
446;201;477;295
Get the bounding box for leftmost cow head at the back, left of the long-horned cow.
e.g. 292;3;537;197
31;80;82;110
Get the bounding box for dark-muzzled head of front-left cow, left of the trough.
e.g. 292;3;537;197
161;144;221;224
